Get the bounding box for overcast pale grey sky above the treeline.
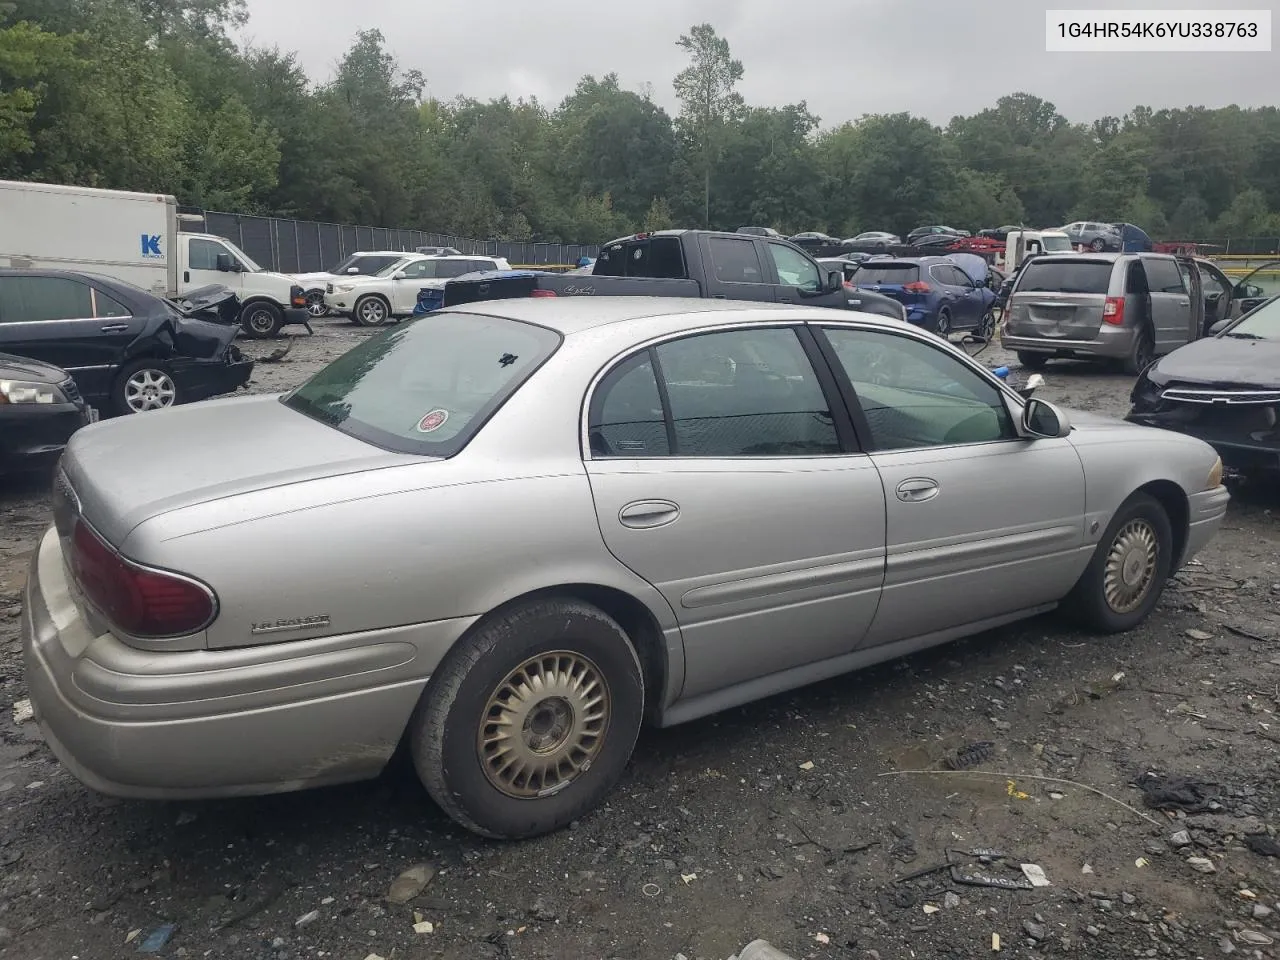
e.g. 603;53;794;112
242;0;1280;127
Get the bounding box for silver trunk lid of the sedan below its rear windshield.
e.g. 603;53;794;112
63;396;422;545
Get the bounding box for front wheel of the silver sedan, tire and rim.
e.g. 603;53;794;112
1064;493;1174;634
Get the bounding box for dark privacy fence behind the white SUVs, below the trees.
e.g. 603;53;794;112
198;212;599;274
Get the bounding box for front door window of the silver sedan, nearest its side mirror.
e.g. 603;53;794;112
826;328;1018;451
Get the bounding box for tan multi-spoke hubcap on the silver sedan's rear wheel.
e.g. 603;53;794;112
476;650;611;800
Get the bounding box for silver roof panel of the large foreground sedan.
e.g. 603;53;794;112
444;297;896;337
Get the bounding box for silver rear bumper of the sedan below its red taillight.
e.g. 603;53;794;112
22;530;474;799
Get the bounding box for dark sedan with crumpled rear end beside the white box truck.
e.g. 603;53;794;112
0;270;253;416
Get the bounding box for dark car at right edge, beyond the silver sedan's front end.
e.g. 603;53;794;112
1126;289;1280;475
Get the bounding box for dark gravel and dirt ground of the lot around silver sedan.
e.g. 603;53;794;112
0;323;1280;960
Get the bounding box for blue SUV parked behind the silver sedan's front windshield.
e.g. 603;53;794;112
852;253;996;339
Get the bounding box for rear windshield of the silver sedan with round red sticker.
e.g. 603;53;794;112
284;311;561;457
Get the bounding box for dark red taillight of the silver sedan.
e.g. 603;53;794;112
72;521;218;640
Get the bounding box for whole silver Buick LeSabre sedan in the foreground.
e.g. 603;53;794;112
23;297;1228;837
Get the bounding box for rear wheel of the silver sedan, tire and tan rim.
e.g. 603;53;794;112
410;599;644;840
